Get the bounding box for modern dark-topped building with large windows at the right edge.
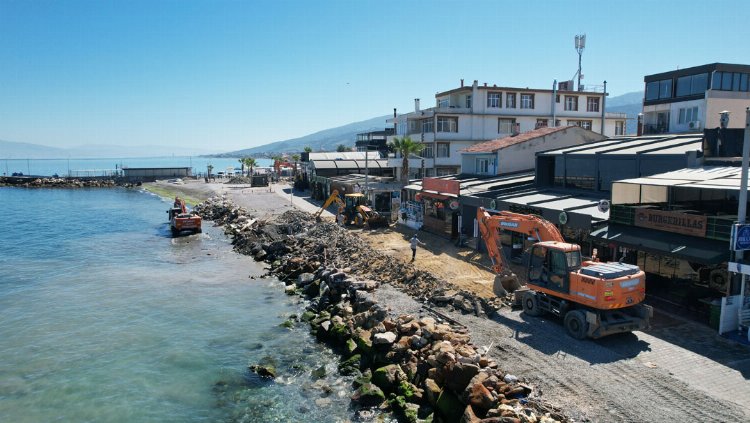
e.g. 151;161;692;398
640;63;750;134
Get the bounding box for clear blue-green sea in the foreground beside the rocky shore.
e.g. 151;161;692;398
0;188;351;422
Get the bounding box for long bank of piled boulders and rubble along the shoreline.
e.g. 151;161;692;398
196;198;566;423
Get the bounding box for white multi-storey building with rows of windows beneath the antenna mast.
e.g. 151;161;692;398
389;80;626;181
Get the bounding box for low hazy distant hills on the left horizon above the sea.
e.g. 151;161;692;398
0;140;213;159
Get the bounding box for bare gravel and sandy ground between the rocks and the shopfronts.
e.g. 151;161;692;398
148;183;750;422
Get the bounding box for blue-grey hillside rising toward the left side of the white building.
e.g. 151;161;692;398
216;115;391;157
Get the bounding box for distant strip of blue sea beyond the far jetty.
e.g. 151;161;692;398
0;157;273;177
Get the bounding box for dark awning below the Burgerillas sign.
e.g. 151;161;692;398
591;224;729;264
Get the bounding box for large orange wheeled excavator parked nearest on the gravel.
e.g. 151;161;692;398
477;207;653;339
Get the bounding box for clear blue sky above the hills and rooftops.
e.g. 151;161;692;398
0;0;750;151
